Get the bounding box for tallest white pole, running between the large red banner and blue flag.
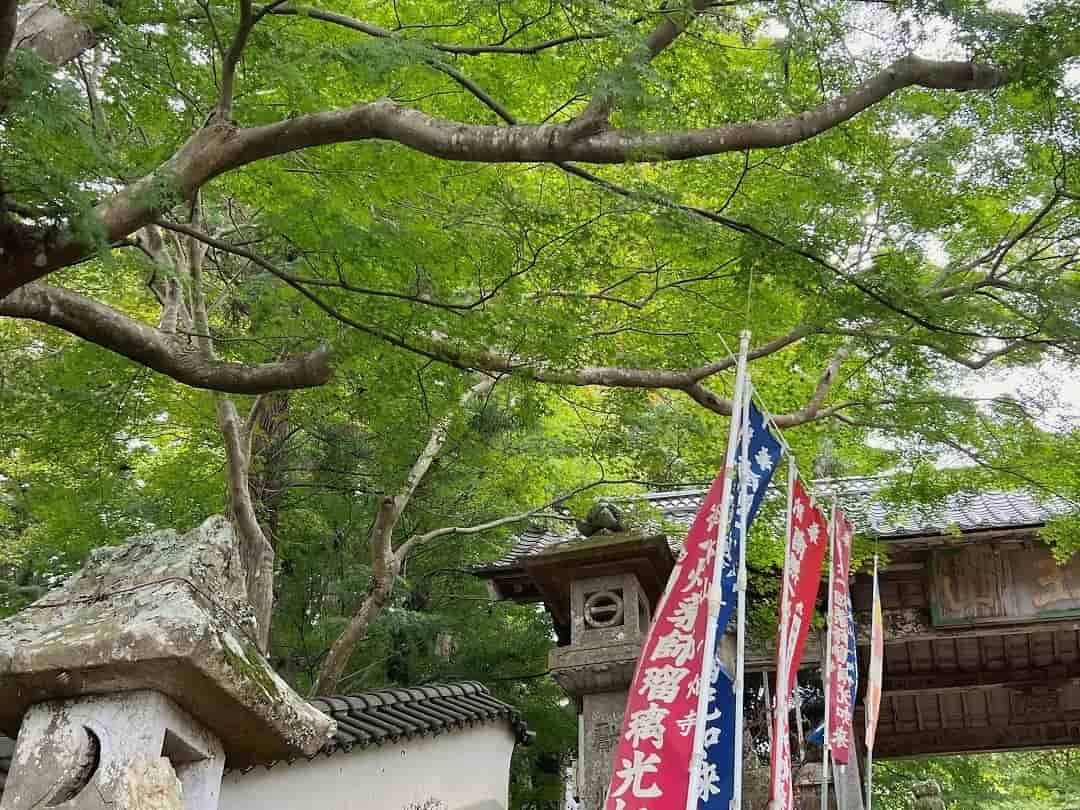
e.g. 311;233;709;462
686;332;750;810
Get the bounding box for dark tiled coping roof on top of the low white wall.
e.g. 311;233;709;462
0;680;534;795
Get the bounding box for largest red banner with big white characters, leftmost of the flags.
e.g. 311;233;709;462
605;471;724;810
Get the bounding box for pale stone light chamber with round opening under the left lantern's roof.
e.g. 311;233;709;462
0;691;225;810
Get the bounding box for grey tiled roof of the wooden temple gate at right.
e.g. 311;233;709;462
477;477;1076;576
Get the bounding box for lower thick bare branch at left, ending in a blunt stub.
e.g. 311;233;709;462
0;283;330;394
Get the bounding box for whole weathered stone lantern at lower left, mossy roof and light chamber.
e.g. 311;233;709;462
0;517;334;810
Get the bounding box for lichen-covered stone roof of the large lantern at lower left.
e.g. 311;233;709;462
0;517;334;767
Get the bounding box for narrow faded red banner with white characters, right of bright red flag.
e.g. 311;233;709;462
826;508;854;765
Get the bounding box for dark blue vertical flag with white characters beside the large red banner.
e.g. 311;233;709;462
692;399;781;810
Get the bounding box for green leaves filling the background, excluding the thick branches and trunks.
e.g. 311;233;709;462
0;0;1080;808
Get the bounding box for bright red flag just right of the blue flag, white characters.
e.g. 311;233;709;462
770;479;828;810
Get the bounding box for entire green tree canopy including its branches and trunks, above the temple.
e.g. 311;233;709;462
0;0;1080;804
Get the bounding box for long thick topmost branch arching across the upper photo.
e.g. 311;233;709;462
0;56;1032;296
